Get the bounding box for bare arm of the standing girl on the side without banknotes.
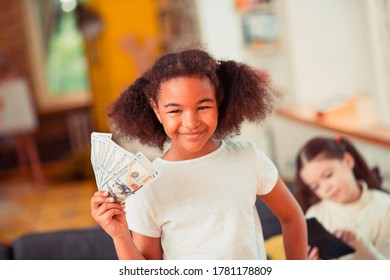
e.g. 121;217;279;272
259;178;308;260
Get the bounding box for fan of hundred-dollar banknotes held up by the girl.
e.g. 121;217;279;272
91;132;159;203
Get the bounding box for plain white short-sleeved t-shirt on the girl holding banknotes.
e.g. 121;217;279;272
126;141;278;260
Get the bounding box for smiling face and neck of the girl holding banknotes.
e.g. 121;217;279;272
150;77;220;160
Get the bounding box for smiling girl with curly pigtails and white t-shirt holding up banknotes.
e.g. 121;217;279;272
91;49;307;259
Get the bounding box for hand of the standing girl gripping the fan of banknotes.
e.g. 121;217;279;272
91;191;129;238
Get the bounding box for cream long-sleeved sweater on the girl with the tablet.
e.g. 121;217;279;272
306;181;390;260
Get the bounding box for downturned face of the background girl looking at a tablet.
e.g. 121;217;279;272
299;153;361;203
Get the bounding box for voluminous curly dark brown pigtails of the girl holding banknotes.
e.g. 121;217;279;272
108;48;280;150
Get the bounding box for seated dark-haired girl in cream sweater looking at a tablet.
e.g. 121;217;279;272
295;136;390;260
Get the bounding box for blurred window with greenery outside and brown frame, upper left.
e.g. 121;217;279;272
25;0;90;111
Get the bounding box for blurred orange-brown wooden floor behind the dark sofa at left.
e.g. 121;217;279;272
0;162;96;244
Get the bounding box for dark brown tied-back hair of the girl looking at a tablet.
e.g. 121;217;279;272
295;136;381;212
